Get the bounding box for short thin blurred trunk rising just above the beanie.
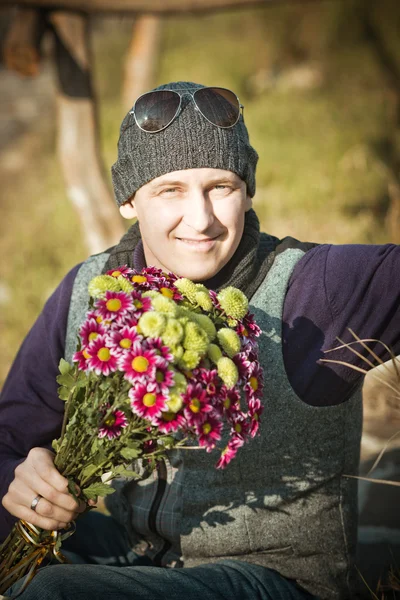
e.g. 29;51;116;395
122;15;161;112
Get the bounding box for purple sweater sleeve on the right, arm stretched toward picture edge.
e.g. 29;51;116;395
283;244;400;406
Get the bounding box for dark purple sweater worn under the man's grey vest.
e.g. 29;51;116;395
0;244;400;540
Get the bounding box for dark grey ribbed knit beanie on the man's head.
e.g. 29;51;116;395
111;81;258;206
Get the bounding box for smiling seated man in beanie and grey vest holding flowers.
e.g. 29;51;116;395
0;82;400;600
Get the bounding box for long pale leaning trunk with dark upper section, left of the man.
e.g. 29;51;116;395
49;12;124;253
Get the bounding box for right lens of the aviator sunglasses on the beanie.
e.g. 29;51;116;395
194;88;240;127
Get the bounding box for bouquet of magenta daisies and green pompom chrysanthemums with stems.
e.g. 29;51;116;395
0;266;262;593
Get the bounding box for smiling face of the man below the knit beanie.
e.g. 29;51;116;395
120;168;251;281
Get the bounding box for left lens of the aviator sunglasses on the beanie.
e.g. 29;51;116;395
134;90;180;132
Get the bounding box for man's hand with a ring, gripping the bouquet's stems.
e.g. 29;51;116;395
2;448;86;530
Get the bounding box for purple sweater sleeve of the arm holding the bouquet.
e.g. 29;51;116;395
0;265;80;540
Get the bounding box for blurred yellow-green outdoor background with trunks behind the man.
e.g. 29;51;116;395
0;0;400;592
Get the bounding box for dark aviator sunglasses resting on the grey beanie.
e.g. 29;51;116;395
130;87;244;133
